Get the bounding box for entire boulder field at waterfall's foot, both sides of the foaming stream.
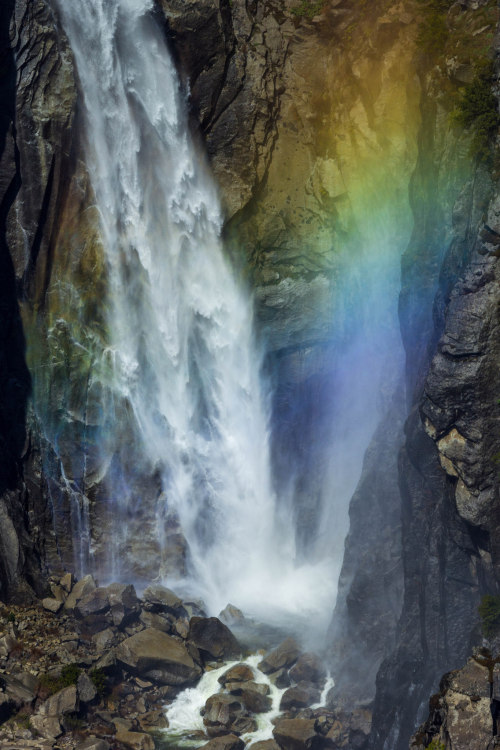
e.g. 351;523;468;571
0;574;371;750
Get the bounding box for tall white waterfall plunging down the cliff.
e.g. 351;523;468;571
53;0;333;625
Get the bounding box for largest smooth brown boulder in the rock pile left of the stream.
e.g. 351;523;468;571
115;628;201;685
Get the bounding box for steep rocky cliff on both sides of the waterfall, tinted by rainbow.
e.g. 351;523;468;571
0;0;500;750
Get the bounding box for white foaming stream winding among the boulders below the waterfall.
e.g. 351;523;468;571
166;654;288;746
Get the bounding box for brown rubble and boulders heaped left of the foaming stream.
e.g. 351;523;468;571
0;574;240;750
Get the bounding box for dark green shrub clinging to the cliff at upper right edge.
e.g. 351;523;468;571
453;60;500;161
